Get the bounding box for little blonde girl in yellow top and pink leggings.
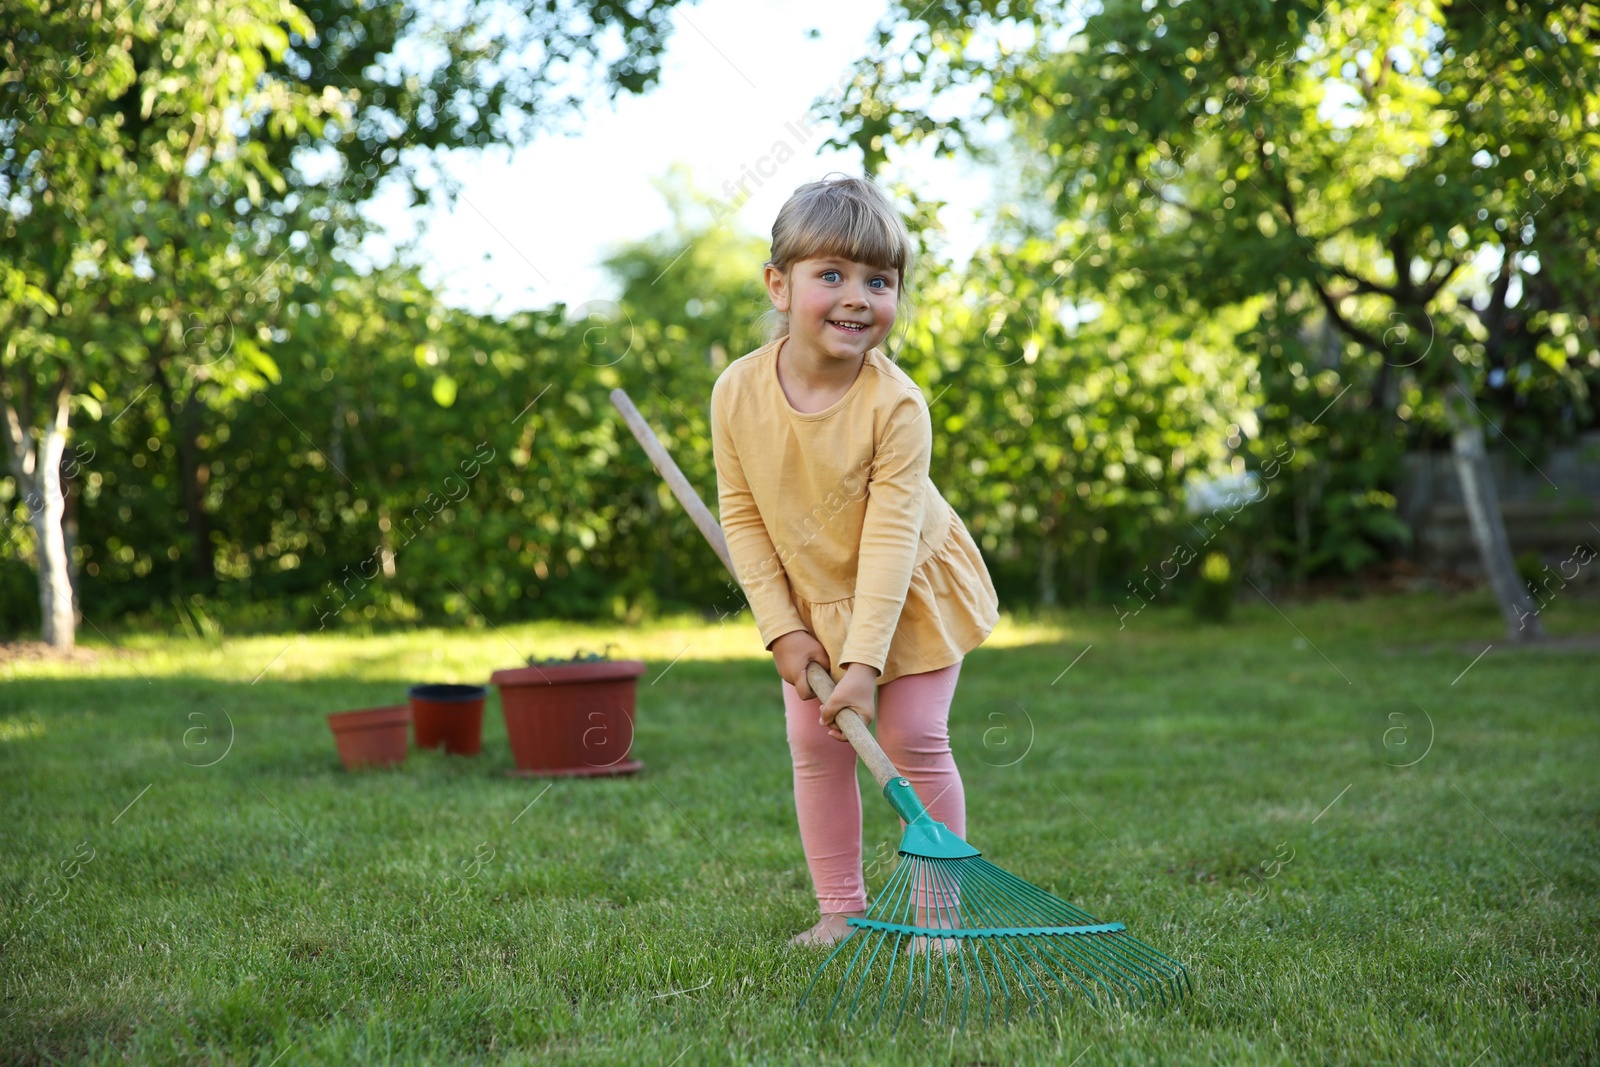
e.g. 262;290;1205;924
710;178;998;945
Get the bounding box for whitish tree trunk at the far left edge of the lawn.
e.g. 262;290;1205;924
5;373;77;649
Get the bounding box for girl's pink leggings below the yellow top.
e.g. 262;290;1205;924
782;662;966;912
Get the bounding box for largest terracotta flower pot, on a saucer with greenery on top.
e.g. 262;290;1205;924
490;659;645;776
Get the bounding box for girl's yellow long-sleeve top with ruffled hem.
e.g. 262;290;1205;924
710;338;1000;685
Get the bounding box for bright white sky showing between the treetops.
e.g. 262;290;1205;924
368;0;992;315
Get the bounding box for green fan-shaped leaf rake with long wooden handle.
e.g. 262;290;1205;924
611;389;1190;1029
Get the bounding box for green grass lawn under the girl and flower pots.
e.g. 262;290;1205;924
0;595;1600;1067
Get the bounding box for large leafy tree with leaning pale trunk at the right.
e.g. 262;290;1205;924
843;0;1600;640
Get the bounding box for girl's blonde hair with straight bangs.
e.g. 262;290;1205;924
763;174;912;341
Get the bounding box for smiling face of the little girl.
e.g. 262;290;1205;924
766;256;899;362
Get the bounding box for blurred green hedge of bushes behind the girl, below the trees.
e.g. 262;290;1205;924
0;174;1587;633
